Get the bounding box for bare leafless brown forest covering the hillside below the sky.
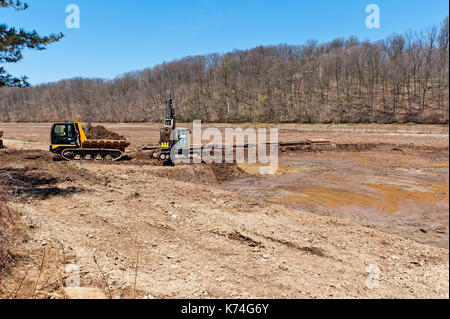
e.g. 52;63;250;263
0;17;449;123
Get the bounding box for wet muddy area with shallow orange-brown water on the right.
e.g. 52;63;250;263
223;150;449;248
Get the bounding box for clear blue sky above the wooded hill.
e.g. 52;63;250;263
0;0;449;84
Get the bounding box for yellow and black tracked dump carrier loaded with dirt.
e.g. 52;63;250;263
50;122;130;161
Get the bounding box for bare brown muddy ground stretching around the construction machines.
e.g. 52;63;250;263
0;124;449;298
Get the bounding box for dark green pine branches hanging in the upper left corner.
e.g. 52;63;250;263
0;0;63;87
